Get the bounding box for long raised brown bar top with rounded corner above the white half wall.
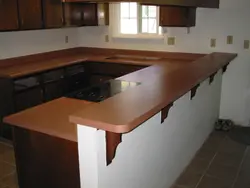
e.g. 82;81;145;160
70;53;237;133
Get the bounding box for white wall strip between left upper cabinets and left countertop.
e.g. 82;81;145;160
0;28;78;59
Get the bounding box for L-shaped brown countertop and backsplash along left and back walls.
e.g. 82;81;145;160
0;48;201;78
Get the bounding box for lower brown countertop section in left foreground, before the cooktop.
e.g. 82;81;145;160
4;97;92;142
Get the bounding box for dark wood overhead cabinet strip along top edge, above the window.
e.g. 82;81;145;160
63;0;219;8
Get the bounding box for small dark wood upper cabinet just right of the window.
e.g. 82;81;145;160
160;6;196;27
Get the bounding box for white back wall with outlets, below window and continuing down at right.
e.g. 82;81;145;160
78;0;250;125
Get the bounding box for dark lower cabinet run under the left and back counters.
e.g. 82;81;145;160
0;62;145;140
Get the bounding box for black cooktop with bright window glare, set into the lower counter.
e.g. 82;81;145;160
66;80;141;102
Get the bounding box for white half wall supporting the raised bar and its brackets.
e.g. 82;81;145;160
78;72;222;188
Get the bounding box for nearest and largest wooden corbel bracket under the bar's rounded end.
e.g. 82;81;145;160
106;131;122;166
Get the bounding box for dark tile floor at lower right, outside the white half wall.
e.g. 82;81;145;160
173;132;250;188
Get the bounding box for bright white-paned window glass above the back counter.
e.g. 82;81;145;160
119;3;161;35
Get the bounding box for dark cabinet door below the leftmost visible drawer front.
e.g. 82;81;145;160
14;86;43;112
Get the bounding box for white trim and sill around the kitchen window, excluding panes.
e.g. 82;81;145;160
109;3;164;39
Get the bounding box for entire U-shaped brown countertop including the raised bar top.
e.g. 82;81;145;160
0;48;237;141
